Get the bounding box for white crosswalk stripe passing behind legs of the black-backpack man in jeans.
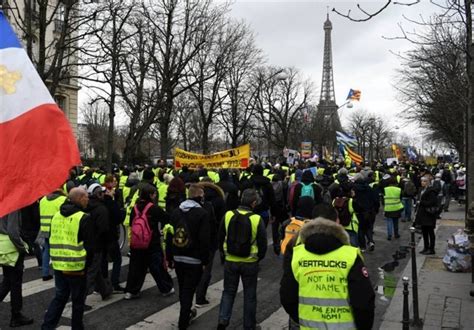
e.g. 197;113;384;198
127;278;260;330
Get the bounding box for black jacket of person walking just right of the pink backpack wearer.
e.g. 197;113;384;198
166;199;211;265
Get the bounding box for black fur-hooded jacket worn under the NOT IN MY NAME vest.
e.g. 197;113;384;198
280;220;375;330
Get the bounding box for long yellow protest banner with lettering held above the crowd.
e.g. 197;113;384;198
174;144;250;168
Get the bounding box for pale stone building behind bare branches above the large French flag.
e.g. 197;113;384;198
0;0;80;136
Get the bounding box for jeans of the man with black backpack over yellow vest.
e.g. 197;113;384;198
219;261;258;329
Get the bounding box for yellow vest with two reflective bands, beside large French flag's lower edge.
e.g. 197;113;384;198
49;211;87;272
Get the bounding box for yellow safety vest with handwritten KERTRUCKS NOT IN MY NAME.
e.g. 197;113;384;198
291;244;358;330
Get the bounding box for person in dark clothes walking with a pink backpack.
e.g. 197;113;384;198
125;184;174;300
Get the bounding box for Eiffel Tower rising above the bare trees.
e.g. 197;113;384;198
316;13;341;152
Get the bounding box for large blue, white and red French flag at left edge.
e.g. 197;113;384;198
0;10;81;217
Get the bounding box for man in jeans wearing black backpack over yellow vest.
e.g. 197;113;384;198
217;189;267;329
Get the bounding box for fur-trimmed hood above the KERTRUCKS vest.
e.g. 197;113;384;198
300;218;349;254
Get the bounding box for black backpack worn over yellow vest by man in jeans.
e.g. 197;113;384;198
226;210;253;258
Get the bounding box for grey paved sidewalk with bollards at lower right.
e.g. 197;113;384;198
377;202;474;330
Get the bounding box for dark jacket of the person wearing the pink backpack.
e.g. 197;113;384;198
130;200;169;251
